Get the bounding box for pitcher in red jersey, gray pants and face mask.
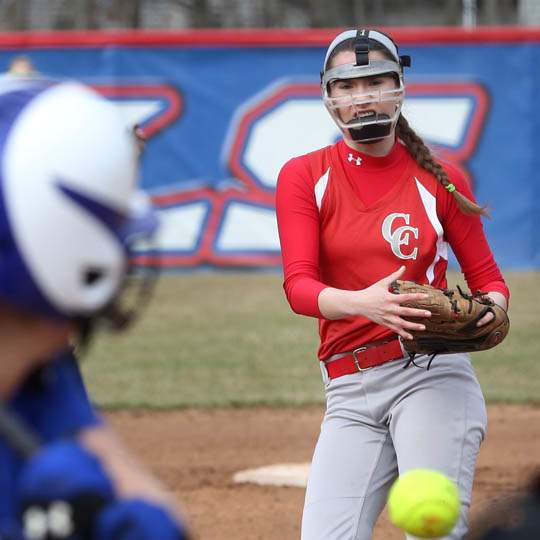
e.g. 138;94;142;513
276;30;509;540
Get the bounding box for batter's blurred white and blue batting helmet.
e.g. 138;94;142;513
0;76;157;320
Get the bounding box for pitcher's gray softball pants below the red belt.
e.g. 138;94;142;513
302;354;487;540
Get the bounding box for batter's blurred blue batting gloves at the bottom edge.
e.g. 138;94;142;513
16;441;188;540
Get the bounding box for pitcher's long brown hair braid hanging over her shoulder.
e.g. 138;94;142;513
396;114;489;216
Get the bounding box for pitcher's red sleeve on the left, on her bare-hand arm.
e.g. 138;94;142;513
276;158;326;318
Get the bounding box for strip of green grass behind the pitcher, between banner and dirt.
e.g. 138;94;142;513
83;272;540;408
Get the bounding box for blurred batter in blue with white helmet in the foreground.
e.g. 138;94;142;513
0;76;185;540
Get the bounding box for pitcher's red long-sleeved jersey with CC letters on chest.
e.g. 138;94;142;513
276;141;509;359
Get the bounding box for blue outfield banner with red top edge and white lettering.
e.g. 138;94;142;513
0;27;540;269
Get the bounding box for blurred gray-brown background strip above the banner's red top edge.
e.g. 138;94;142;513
0;0;540;30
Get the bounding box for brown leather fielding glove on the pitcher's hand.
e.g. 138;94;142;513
390;280;510;357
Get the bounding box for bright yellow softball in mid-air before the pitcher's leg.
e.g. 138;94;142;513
388;469;460;538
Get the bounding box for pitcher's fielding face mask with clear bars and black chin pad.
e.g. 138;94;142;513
321;30;411;142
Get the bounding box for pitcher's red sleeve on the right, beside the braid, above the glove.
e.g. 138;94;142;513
437;163;510;300
